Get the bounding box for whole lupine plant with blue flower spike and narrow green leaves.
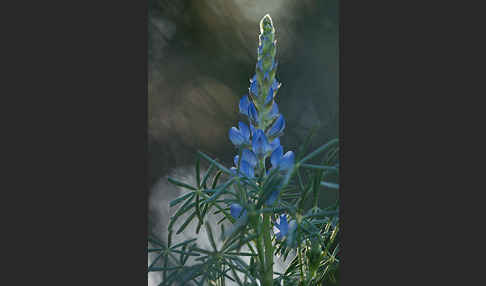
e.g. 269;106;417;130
148;15;340;286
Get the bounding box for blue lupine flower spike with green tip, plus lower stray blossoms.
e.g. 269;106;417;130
229;14;294;238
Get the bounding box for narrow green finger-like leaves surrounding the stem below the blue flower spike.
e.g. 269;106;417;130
148;138;339;285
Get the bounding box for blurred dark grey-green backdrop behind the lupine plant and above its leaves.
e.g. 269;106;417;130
148;0;339;284
